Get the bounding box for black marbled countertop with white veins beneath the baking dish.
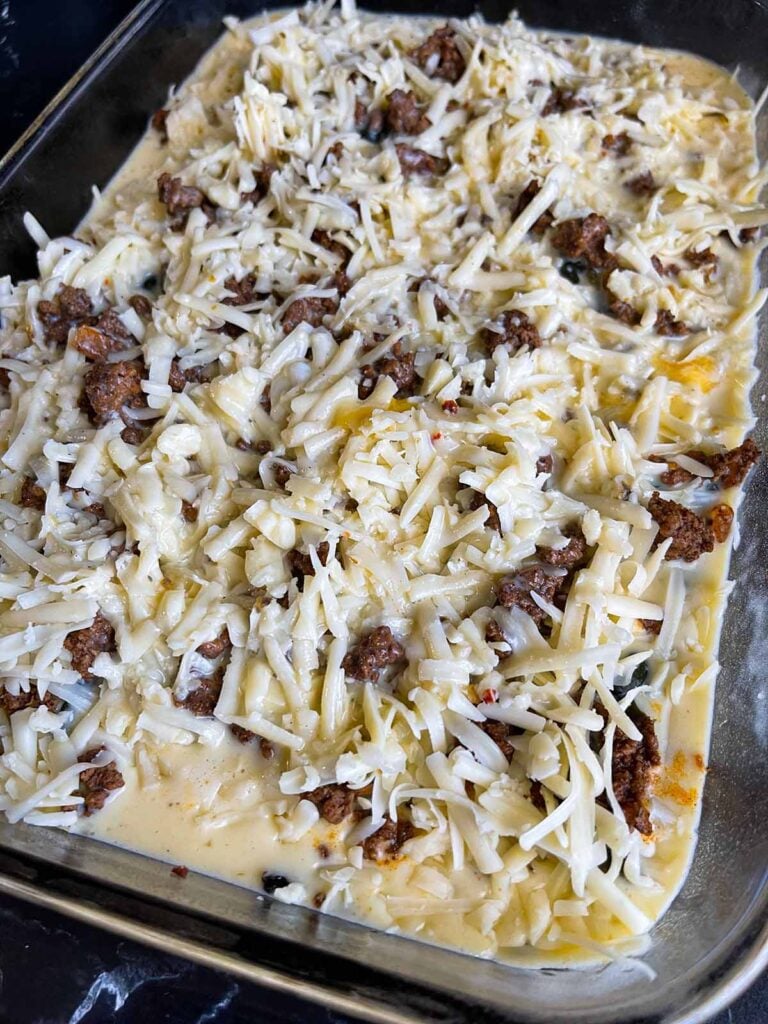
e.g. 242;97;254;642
0;0;768;1024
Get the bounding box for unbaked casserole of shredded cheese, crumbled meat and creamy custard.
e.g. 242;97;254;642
0;0;768;965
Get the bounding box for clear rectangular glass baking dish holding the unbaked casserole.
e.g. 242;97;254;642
0;0;768;1024
